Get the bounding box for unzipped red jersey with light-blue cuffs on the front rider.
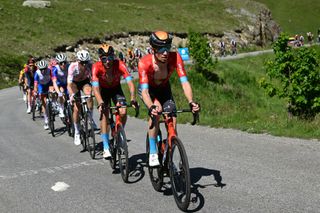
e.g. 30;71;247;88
138;52;188;89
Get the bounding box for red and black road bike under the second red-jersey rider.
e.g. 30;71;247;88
100;102;139;183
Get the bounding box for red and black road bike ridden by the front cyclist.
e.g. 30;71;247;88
146;109;199;211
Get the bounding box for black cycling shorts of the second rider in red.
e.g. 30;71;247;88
100;84;127;106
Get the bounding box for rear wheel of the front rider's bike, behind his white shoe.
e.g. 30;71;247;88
146;134;163;192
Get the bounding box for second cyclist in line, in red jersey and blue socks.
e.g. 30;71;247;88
92;44;137;158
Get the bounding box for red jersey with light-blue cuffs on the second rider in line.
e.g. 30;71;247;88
92;59;132;88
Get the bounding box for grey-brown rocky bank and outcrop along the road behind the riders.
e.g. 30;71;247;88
50;8;281;60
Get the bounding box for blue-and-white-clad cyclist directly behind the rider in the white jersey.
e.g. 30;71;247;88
52;53;69;118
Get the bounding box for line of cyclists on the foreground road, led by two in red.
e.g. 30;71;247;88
19;31;200;167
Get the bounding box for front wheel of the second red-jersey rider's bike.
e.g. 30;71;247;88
116;125;130;183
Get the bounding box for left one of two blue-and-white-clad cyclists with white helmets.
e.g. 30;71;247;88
34;60;52;130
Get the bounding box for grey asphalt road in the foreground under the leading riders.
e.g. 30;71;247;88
0;87;320;213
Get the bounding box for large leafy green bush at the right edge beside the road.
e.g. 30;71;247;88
261;34;320;119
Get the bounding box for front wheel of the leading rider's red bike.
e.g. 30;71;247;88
169;137;191;211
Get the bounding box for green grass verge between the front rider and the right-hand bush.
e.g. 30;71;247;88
125;47;320;139
